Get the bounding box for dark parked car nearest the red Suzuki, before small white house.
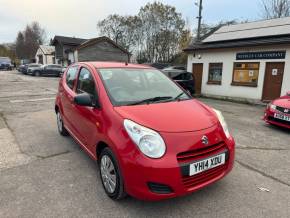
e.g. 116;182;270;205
28;64;62;76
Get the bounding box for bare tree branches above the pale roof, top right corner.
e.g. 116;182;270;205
261;0;290;19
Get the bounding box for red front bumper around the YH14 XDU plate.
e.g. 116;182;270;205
118;127;235;200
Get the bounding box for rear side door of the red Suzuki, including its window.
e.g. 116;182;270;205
59;65;80;137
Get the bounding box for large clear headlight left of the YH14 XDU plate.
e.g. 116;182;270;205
124;119;166;158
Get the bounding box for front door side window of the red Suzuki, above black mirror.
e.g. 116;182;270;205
77;68;96;96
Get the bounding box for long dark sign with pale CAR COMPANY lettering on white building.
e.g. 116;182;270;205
236;51;286;60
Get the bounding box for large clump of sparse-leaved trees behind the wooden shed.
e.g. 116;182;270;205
97;2;185;62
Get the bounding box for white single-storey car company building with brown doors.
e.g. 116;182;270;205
185;17;290;101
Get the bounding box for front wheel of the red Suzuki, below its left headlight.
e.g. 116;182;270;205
99;147;127;200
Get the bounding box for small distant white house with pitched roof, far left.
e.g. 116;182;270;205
35;45;55;64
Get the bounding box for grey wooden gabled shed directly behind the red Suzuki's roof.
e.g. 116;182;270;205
73;36;130;62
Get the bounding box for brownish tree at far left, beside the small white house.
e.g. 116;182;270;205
15;22;46;59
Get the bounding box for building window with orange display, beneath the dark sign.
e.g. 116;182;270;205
232;62;260;87
